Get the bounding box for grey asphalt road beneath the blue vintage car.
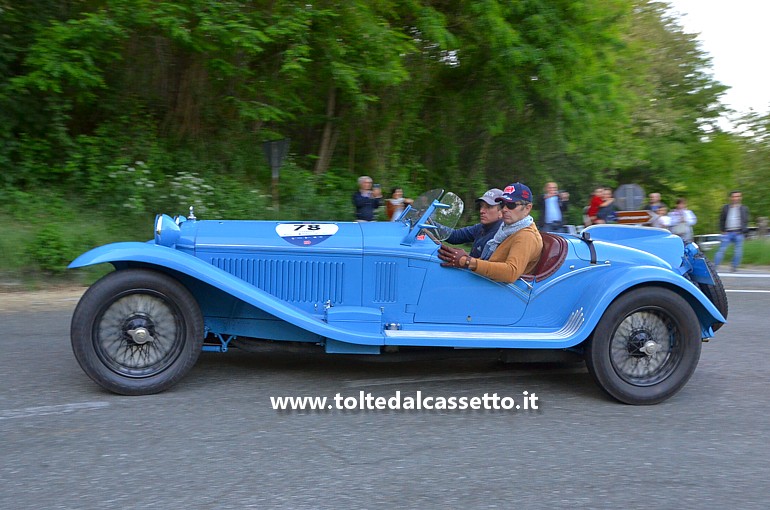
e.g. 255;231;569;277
0;273;770;509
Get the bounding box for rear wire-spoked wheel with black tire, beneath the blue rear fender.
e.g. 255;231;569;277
585;287;701;405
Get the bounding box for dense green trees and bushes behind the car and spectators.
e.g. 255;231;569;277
0;0;770;258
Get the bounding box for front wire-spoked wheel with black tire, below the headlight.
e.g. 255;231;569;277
71;269;204;395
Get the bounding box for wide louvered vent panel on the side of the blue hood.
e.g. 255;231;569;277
211;257;345;305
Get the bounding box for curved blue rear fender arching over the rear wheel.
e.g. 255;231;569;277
582;266;726;338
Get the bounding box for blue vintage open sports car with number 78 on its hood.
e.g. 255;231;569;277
70;190;727;404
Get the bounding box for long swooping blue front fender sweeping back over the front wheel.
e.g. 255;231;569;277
68;242;384;345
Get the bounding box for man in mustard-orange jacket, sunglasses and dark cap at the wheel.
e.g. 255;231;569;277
438;182;543;283
